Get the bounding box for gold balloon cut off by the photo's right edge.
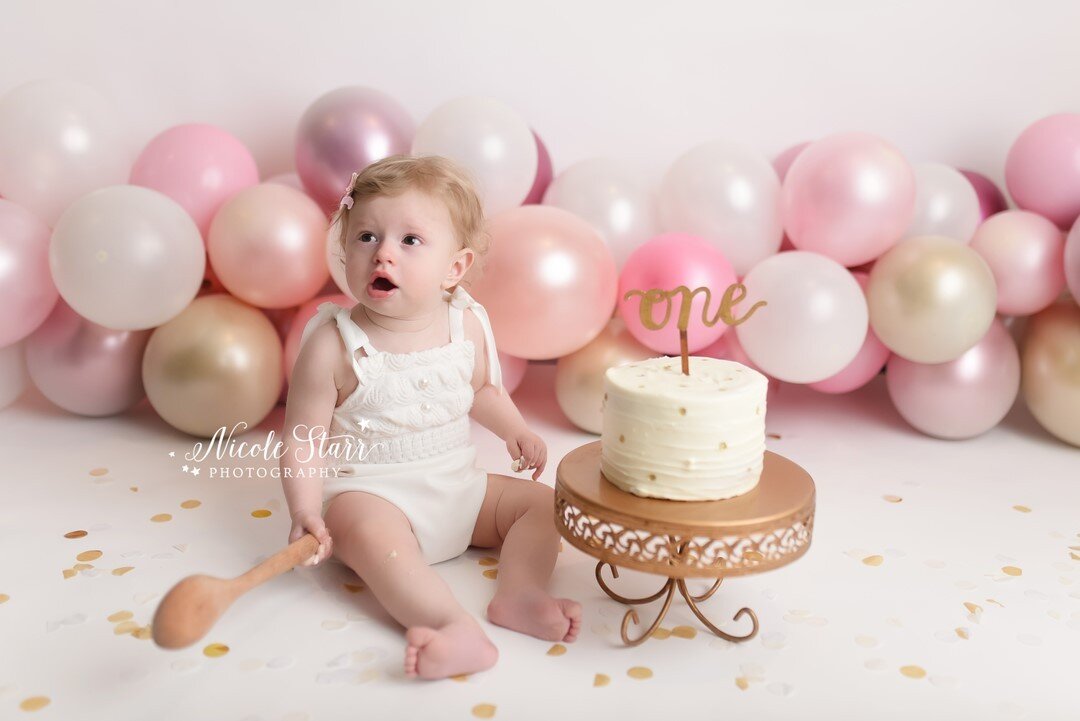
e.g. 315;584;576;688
1021;300;1080;446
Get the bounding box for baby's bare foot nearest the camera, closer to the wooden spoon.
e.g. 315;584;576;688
405;616;499;679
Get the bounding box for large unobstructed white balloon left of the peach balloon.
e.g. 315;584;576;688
49;186;206;330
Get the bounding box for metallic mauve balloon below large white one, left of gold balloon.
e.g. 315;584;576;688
26;299;153;416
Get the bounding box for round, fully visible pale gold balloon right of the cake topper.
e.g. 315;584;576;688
866;235;997;363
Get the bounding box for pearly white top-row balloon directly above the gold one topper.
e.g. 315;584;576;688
658;140;784;276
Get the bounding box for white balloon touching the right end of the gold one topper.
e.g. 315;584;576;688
734;250;869;383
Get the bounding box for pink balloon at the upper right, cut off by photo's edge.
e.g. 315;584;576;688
1005;112;1080;230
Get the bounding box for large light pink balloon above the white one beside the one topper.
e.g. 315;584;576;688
782;133;915;267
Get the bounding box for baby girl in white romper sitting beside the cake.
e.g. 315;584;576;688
282;155;581;679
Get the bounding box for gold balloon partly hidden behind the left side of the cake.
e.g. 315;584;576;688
555;317;659;435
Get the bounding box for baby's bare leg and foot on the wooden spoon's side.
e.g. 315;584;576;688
325;491;499;679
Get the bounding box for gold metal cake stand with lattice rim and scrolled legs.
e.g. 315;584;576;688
555;440;814;645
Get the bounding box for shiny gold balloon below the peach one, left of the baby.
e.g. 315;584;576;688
143;294;283;437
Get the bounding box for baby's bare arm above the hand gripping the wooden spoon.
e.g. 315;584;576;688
281;324;342;516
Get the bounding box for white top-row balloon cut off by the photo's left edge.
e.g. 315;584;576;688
0;79;135;226
